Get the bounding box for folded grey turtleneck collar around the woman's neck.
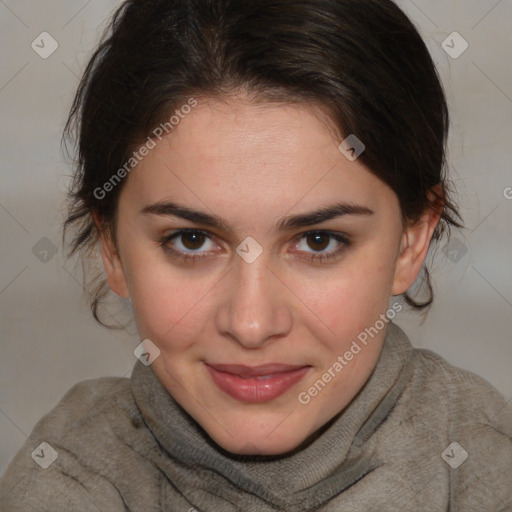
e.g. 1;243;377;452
131;321;412;510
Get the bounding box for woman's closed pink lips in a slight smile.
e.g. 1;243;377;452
205;363;311;403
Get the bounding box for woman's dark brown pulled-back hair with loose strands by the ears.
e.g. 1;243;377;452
63;0;462;325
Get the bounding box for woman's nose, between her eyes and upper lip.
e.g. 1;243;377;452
216;256;292;348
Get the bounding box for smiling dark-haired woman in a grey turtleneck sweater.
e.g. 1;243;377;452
0;0;512;511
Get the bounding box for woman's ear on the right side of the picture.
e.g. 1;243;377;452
391;184;444;295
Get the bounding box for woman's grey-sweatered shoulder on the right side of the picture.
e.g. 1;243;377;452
409;349;512;504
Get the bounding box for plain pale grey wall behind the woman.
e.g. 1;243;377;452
0;0;512;472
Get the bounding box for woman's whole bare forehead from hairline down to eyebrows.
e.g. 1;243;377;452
119;99;394;223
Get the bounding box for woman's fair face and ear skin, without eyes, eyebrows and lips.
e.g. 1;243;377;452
95;96;441;455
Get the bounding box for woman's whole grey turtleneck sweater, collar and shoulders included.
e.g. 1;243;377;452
0;322;512;512
